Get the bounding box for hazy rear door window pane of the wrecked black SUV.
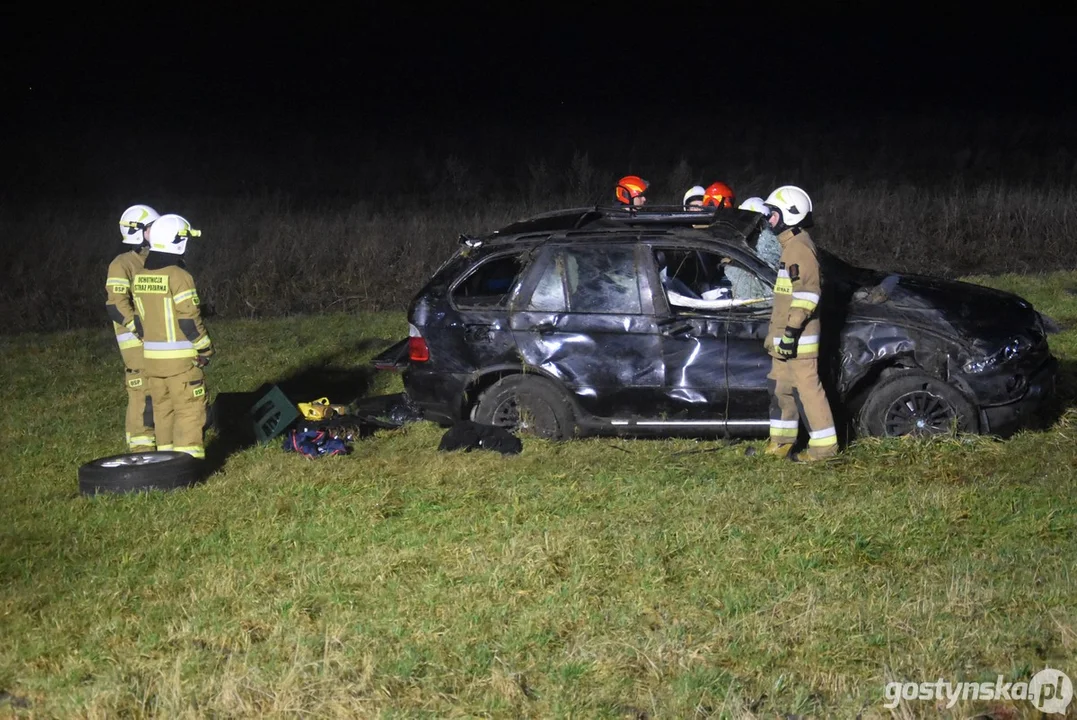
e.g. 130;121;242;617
562;246;642;314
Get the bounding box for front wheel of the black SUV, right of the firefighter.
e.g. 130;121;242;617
856;370;980;437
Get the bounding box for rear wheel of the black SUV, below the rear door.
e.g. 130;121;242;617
473;375;576;440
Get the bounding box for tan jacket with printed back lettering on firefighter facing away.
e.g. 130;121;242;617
131;253;213;378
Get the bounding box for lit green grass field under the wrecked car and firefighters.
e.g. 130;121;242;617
0;272;1077;718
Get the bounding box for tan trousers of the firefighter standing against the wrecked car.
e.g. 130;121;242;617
767;357;838;458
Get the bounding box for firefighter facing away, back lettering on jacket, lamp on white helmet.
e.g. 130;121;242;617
131;215;213;458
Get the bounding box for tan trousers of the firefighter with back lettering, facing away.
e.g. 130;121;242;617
149;367;207;457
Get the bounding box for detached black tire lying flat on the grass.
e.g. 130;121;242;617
79;450;205;495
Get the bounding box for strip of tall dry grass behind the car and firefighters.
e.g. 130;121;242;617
0;178;1077;333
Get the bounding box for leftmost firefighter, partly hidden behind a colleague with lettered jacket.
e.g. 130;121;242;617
104;204;158;452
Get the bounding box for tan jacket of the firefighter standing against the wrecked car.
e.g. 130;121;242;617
767;227;822;358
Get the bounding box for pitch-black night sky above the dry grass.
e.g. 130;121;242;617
0;8;1077;204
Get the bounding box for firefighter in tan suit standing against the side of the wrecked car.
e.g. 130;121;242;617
766;185;838;462
